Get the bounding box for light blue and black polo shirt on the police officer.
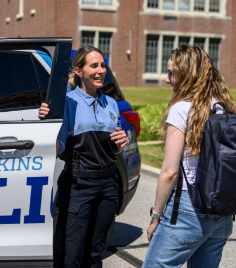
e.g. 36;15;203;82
58;86;121;170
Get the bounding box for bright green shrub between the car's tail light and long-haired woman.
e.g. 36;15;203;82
138;103;168;135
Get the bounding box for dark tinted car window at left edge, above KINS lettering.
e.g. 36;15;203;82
0;53;41;109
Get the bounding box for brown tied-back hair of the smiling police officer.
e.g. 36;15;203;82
68;46;102;90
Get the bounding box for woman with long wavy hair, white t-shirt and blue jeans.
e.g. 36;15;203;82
143;45;236;268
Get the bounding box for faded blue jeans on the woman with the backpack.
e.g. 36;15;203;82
142;191;233;268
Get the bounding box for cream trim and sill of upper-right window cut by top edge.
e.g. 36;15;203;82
139;0;231;19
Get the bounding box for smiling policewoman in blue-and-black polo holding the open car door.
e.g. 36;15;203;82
39;47;128;268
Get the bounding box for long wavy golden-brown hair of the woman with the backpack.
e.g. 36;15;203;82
161;45;236;155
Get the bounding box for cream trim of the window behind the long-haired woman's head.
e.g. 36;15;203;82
142;30;225;80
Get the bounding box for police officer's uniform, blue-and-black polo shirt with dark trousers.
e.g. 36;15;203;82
57;87;121;268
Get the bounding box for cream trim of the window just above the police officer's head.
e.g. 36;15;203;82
79;25;117;67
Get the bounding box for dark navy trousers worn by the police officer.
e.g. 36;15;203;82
57;171;118;268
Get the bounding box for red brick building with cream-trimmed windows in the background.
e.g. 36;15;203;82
0;0;236;88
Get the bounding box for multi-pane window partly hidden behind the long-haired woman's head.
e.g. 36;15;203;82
142;30;224;80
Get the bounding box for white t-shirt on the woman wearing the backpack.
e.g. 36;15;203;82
166;98;223;190
